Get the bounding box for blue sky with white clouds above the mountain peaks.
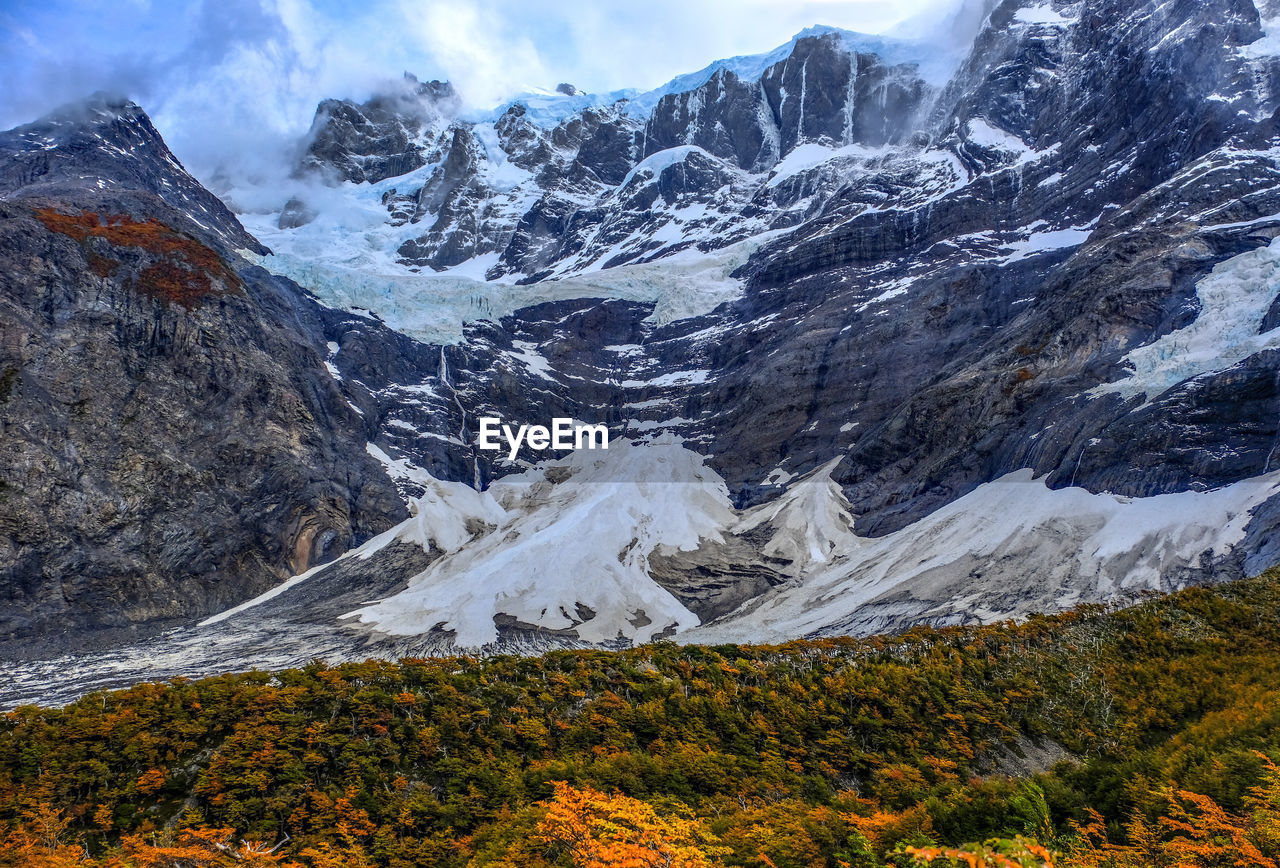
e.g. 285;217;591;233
0;0;955;175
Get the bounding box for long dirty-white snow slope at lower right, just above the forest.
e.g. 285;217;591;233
681;470;1280;643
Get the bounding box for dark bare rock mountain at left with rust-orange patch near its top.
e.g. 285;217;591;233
0;97;406;654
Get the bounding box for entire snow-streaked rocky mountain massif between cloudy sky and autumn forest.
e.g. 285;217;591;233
0;0;1280;698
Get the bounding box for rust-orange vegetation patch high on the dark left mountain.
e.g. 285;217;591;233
36;207;239;310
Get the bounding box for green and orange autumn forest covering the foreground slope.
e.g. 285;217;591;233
0;571;1280;868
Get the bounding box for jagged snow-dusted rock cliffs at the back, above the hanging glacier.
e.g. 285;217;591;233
287;28;934;280
